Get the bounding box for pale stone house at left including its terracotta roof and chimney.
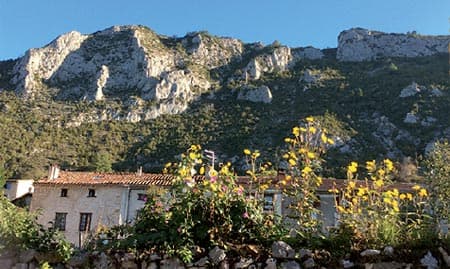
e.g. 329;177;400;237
31;167;172;247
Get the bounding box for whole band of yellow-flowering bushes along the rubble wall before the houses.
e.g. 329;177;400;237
85;120;450;268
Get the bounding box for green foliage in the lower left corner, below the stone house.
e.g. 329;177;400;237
0;196;72;261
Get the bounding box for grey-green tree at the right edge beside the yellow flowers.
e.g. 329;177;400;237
425;141;450;225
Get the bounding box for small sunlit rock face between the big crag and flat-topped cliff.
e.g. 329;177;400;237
243;46;295;80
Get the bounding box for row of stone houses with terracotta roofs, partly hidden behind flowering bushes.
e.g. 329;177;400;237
31;167;418;247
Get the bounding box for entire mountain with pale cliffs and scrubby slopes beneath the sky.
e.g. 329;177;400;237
0;26;450;177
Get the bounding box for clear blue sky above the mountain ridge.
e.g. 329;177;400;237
0;0;450;60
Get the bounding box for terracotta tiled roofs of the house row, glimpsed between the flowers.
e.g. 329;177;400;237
35;171;414;192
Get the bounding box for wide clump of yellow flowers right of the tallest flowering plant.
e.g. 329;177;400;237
330;159;433;249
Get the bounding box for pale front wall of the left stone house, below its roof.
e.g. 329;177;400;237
31;184;146;246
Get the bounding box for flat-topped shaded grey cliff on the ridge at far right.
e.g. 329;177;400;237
337;28;450;61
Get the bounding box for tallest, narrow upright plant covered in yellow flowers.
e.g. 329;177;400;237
279;117;334;239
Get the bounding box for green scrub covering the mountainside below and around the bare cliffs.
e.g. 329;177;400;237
0;50;450;178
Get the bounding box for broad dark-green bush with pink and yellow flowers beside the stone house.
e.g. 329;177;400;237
135;145;280;262
